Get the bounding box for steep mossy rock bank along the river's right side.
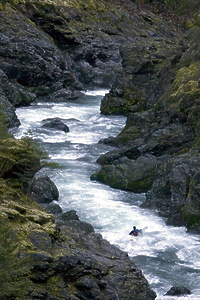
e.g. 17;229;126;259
92;1;200;233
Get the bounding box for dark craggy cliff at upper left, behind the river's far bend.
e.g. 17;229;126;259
0;1;123;126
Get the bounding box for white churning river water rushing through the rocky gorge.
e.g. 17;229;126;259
13;90;200;300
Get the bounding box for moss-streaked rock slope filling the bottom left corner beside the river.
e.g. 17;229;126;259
0;171;156;300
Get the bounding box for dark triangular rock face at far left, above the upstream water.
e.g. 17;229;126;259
0;5;80;106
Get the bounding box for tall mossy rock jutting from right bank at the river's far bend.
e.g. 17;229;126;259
101;33;184;115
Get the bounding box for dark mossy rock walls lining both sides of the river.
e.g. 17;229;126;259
0;0;200;300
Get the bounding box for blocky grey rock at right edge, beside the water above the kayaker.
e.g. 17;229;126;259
142;153;200;232
